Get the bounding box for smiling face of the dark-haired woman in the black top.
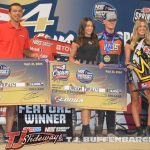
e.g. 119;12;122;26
84;21;94;37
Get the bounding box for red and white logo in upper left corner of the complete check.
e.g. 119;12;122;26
52;65;69;80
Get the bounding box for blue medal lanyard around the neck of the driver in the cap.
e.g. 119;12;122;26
104;33;115;54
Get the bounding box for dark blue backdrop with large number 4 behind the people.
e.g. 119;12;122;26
0;0;150;148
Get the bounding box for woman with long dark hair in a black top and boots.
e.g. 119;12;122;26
69;17;99;137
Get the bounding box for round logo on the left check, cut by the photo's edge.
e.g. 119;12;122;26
0;65;10;79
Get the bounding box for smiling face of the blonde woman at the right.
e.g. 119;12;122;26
137;22;147;37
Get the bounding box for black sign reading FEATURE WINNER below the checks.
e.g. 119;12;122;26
18;105;73;144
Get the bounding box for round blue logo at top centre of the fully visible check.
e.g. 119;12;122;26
76;69;93;83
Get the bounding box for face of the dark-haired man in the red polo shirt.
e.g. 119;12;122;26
9;6;23;22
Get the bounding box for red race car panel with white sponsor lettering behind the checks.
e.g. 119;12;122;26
30;33;71;61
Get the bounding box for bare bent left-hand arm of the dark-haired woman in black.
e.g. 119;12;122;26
69;42;80;64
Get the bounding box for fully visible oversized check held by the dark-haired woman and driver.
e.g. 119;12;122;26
50;62;127;111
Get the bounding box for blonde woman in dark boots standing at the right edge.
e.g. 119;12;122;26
125;19;150;136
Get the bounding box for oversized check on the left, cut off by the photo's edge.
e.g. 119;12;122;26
0;59;50;105
